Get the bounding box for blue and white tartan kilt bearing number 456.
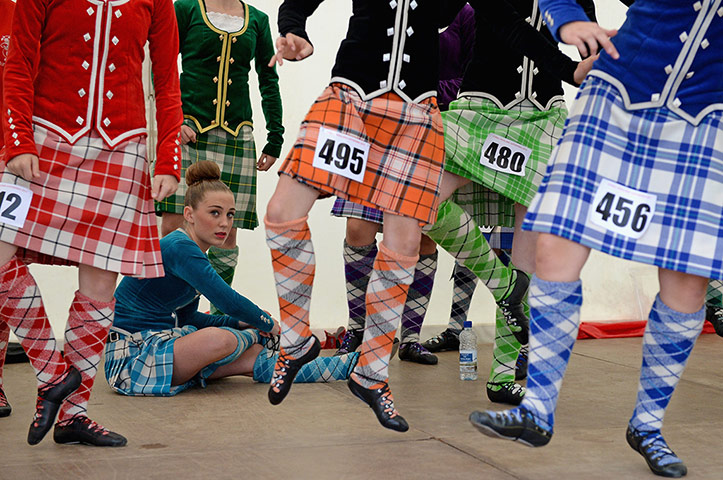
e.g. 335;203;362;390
522;76;723;278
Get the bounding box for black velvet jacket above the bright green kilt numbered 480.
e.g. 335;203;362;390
460;0;595;110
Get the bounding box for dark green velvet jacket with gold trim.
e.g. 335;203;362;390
174;0;284;157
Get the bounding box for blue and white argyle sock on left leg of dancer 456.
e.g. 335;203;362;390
520;276;582;432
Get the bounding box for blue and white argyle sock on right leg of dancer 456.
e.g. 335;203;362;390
630;296;705;432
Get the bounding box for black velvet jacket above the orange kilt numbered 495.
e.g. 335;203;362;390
278;0;470;102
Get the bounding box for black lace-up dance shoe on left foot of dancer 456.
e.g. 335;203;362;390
469;407;552;447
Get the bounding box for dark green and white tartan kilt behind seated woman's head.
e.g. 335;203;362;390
156;120;259;230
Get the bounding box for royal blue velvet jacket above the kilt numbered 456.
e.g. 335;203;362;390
540;0;723;125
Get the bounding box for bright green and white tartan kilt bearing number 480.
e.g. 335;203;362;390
442;95;567;210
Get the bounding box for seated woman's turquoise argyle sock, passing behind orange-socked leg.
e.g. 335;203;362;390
254;348;359;383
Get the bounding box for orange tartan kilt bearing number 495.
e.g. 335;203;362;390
279;83;444;223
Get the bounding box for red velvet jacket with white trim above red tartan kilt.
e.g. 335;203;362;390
2;0;183;178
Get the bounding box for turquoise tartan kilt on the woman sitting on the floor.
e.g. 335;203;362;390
105;325;199;397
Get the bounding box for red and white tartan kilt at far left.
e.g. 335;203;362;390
0;125;163;278
